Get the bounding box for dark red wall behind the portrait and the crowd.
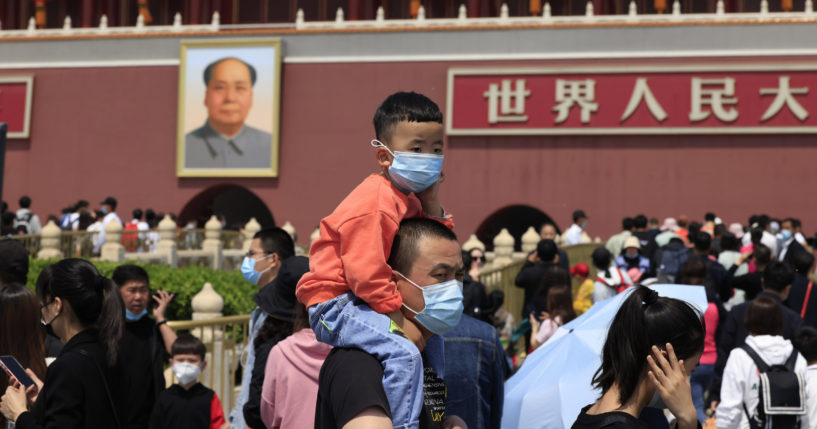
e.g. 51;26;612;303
6;58;817;243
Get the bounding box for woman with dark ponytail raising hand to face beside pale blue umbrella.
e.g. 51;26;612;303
573;287;705;429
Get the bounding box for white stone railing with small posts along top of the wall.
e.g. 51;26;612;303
0;0;817;40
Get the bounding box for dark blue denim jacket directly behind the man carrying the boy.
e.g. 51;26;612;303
443;315;507;429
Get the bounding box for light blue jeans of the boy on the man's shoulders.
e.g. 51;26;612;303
309;292;423;429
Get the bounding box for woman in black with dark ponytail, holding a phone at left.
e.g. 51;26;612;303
0;259;127;429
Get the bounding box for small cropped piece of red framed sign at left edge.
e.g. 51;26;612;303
0;76;34;139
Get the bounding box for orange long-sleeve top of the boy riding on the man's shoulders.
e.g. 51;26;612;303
295;174;454;314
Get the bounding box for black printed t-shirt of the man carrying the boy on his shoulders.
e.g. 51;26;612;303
315;348;445;429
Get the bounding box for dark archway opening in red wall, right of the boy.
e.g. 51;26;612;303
474;204;562;251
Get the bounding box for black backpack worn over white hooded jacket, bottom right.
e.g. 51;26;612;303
740;343;806;429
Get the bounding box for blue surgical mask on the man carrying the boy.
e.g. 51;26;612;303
395;271;463;334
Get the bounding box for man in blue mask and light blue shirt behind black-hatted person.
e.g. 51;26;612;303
228;227;295;428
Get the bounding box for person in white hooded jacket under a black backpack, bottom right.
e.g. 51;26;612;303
715;296;812;429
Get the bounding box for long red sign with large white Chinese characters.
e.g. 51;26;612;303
446;64;817;135
